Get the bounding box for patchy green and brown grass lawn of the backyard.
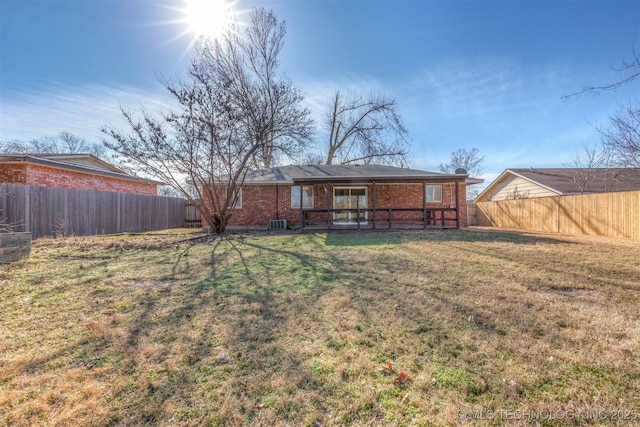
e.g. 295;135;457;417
0;230;640;427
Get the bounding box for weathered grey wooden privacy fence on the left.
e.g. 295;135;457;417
0;183;185;239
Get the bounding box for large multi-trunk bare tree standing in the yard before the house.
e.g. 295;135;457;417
103;9;312;233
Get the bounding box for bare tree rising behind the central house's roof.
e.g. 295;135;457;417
325;91;409;166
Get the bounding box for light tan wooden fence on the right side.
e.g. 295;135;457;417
477;191;640;240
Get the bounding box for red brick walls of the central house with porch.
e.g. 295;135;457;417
209;183;467;228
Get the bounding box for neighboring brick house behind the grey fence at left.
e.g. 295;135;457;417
0;154;162;196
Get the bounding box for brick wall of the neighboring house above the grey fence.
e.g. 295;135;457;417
0;164;158;196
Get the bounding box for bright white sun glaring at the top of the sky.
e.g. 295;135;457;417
184;0;234;39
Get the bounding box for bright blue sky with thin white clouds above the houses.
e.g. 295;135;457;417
0;0;640;186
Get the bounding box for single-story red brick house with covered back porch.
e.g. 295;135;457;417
218;165;482;229
